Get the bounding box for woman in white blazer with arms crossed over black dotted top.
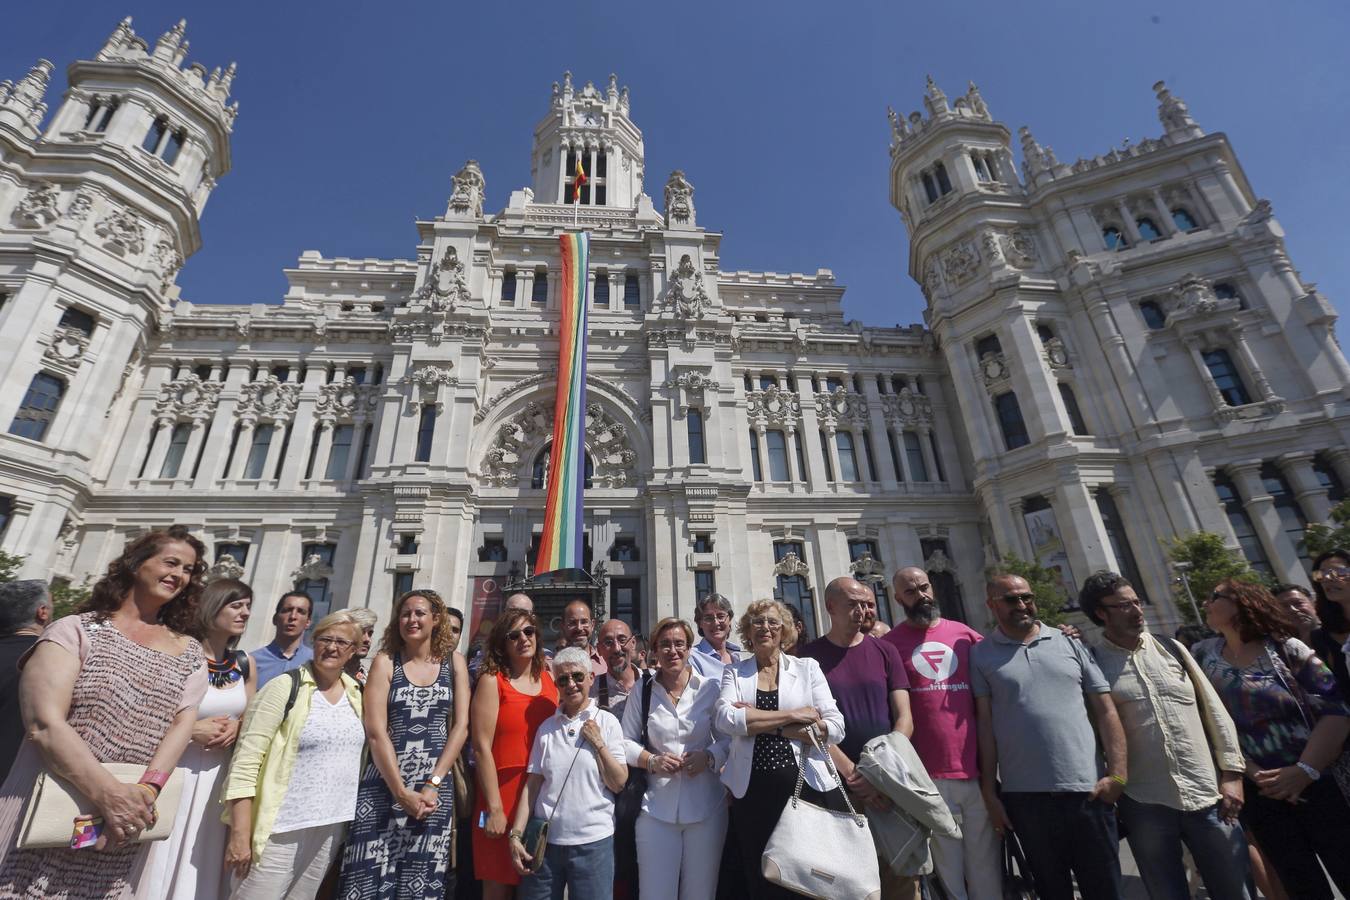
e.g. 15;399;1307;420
716;600;844;900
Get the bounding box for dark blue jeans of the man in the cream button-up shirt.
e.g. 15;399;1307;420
1119;796;1251;900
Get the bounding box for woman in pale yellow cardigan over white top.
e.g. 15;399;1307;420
224;613;366;900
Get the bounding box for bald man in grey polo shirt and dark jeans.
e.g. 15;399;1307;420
971;575;1126;900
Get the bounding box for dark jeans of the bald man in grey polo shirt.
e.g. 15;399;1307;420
1003;791;1125;900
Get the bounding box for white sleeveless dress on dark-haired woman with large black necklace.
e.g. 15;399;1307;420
149;658;248;900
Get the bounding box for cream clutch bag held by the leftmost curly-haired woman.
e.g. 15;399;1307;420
16;762;182;850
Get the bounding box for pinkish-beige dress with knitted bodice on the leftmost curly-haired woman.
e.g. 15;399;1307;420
0;613;207;900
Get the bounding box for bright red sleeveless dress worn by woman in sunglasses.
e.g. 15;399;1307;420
473;669;558;884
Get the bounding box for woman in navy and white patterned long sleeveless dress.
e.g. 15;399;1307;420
338;590;468;900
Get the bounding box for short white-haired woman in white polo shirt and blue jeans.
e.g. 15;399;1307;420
509;646;628;900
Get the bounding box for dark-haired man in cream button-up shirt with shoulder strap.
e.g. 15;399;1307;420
1079;572;1250;899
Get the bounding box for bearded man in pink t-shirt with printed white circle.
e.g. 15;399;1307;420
882;565;1003;900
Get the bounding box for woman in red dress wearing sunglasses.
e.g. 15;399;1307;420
468;609;558;900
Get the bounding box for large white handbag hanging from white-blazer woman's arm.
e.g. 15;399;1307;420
760;726;882;900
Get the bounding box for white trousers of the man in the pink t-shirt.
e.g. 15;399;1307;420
929;779;1003;900
